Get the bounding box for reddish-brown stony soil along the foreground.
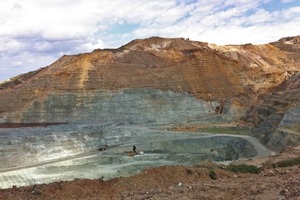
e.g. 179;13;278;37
0;146;300;200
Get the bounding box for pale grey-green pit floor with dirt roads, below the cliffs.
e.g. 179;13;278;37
0;123;271;188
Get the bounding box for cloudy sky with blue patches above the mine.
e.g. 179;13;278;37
0;0;300;81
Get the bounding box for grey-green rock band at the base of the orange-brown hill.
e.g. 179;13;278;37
21;89;237;124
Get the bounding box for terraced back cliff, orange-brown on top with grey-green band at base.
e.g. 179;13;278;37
0;37;300;137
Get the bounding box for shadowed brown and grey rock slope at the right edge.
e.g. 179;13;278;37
248;73;300;150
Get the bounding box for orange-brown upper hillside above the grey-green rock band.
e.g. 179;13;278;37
0;37;300;123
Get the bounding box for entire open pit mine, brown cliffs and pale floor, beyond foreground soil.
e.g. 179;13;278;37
0;36;300;188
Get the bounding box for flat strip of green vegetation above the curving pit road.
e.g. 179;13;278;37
200;126;251;135
